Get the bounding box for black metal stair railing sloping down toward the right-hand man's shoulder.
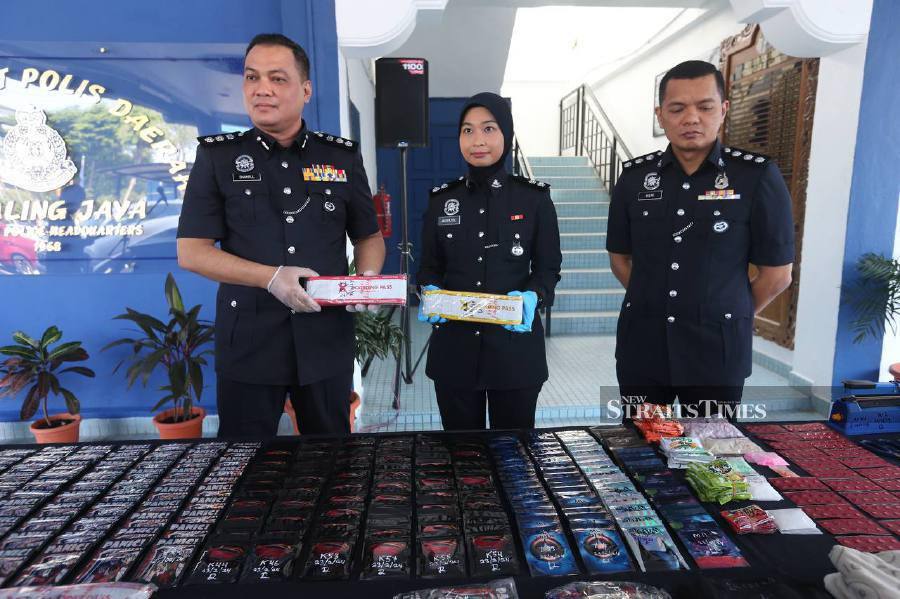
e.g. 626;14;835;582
559;84;632;192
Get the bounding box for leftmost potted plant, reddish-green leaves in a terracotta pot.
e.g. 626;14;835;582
0;326;94;443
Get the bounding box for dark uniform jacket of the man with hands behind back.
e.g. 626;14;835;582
606;142;794;386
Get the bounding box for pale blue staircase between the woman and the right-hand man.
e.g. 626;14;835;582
529;156;625;335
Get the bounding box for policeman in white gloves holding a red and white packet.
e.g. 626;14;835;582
178;34;384;437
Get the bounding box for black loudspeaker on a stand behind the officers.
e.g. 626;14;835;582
375;58;428;148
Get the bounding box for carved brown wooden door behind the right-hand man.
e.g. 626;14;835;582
720;25;819;349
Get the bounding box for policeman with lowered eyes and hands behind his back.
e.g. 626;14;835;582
606;61;794;416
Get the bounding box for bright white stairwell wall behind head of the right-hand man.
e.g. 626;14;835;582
593;7;744;155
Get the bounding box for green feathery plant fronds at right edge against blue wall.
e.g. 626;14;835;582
848;252;900;343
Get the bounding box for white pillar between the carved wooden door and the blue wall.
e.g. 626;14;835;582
793;44;866;387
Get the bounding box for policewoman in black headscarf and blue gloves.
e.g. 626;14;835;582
417;93;562;430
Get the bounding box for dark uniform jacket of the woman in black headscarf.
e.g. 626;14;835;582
417;170;562;389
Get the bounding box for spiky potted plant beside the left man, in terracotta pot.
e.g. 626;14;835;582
103;273;214;439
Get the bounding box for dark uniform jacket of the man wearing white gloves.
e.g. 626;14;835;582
178;123;378;385
